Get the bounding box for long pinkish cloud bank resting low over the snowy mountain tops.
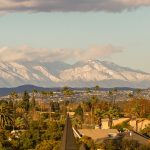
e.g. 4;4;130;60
0;45;122;62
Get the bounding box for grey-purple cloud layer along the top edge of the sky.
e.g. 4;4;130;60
0;0;150;13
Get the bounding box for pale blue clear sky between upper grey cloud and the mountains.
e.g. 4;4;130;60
0;1;150;73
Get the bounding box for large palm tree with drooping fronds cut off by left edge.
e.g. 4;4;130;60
0;103;13;129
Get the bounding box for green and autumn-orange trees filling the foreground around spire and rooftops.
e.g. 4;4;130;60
0;86;150;150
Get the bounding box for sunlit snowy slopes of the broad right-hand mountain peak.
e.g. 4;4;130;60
60;61;150;82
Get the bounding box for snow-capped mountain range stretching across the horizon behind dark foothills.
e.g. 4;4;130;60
0;60;150;88
